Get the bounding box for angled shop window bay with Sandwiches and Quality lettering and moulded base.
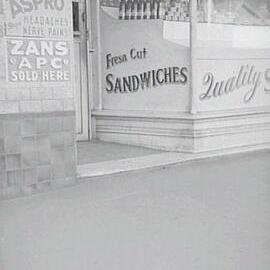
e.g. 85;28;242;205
92;0;270;155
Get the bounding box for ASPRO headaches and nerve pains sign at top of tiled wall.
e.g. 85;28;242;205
5;0;72;39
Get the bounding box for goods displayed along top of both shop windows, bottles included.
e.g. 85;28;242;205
101;0;270;26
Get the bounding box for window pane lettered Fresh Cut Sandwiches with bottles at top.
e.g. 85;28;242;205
100;0;190;112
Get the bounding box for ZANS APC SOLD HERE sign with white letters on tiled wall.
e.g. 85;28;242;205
7;39;71;82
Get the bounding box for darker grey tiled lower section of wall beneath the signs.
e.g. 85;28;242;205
0;112;76;199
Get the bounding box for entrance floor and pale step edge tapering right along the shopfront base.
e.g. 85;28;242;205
77;141;270;180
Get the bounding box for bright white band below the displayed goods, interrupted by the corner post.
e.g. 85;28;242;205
163;21;270;49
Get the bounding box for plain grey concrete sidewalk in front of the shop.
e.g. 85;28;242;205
0;151;270;270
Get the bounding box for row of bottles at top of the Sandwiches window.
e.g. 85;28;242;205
119;0;165;20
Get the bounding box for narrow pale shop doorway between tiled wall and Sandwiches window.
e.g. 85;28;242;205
72;0;92;141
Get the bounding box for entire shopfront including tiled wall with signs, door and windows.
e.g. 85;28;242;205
0;0;270;197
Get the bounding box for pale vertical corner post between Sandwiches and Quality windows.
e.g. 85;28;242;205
189;0;198;114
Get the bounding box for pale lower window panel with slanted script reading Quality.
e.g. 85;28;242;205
198;59;270;110
